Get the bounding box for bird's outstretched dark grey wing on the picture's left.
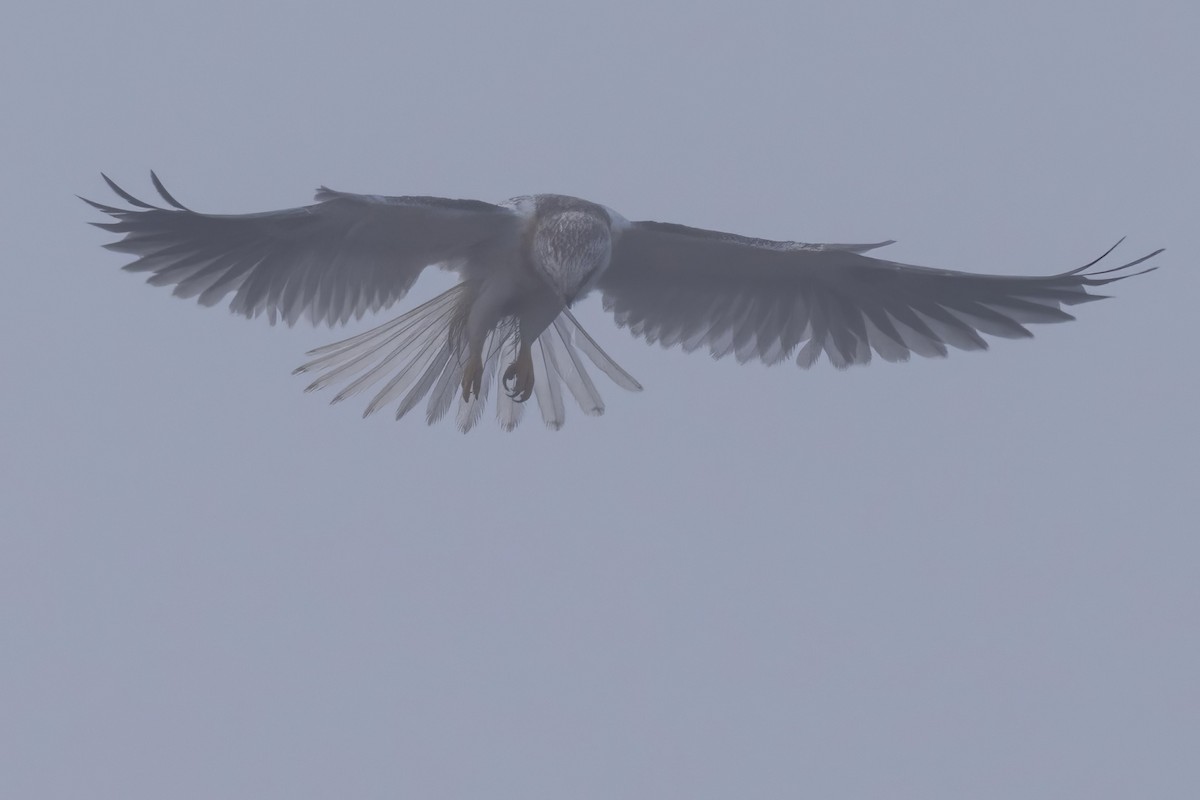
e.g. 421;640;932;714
82;173;520;325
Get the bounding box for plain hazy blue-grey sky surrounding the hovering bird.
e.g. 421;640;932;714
0;0;1200;800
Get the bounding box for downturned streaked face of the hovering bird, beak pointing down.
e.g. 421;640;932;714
530;209;612;306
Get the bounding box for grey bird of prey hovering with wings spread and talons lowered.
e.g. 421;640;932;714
79;172;1163;432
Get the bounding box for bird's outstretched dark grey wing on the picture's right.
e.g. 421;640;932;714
598;222;1162;368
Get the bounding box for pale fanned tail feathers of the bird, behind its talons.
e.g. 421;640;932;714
295;284;642;433
